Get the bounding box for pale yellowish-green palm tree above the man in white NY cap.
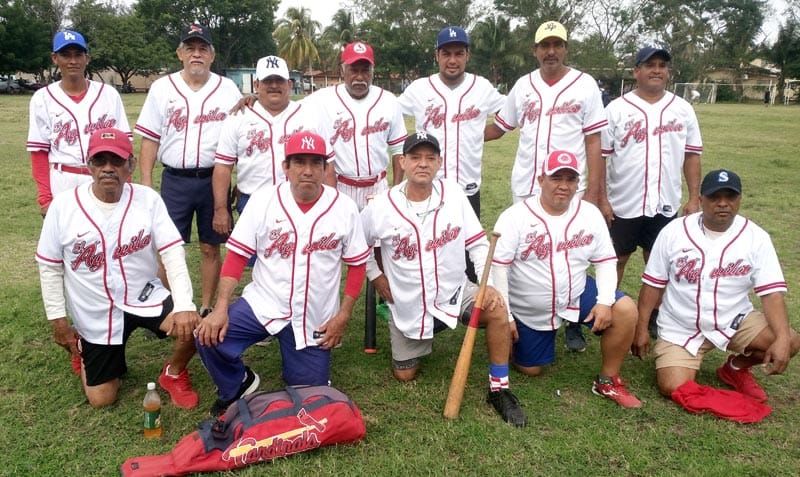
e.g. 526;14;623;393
272;7;321;71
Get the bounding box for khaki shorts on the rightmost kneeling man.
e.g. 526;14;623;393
653;310;769;370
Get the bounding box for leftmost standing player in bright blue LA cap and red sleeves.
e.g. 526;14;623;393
26;30;130;216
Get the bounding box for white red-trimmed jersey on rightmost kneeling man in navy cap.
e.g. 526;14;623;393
642;212;786;355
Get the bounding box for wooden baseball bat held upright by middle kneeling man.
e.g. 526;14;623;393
444;232;500;419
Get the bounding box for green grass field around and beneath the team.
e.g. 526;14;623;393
0;94;800;477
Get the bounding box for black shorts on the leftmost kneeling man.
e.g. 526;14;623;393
79;296;173;386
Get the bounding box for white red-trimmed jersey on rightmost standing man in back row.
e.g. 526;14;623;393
602;91;703;219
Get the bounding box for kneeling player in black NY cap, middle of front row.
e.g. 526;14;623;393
361;132;527;427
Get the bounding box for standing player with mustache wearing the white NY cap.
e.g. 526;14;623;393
212;56;304;235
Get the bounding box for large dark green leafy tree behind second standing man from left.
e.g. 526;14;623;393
139;0;279;71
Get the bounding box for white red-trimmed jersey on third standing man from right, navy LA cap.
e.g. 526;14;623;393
398;73;506;195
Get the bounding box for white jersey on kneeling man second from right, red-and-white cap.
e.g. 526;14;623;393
492;195;617;330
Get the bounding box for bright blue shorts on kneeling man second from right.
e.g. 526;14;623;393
512;275;625;367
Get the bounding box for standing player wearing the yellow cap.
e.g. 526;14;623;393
485;21;611;351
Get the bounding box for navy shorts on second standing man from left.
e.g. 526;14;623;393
161;168;228;244
